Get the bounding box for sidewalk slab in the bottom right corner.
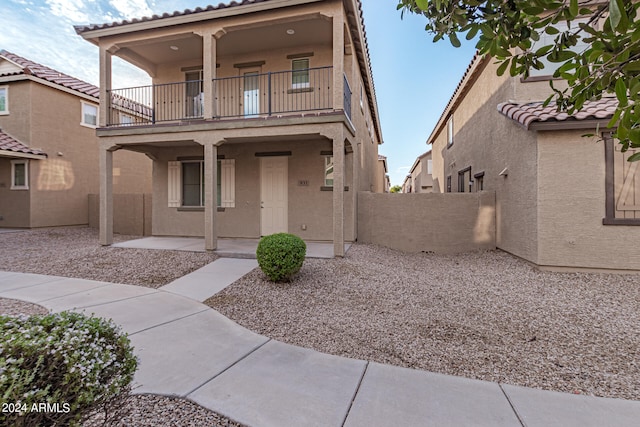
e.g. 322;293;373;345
502;384;640;427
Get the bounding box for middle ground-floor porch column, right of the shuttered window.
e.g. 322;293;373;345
204;141;218;251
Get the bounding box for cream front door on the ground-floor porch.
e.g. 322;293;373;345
260;157;289;236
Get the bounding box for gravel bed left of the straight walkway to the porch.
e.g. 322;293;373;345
0;227;217;288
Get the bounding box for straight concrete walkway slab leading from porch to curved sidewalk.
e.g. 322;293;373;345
160;258;258;301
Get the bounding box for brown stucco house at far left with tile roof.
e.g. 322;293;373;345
0;50;151;228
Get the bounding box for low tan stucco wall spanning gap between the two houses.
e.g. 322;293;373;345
358;192;496;253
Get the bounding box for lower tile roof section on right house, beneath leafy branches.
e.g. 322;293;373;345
498;97;618;130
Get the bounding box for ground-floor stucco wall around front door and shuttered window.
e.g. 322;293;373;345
152;140;355;241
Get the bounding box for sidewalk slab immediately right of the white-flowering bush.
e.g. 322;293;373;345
129;310;269;396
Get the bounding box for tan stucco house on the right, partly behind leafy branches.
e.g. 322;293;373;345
427;52;640;270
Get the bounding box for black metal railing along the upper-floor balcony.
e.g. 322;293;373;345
107;66;351;127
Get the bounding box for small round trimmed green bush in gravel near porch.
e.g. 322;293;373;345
256;233;307;282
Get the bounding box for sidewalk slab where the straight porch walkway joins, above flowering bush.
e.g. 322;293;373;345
72;292;208;334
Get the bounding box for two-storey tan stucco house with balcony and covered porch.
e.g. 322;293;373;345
76;0;382;256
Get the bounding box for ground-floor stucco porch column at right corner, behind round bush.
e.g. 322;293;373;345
333;129;344;257
